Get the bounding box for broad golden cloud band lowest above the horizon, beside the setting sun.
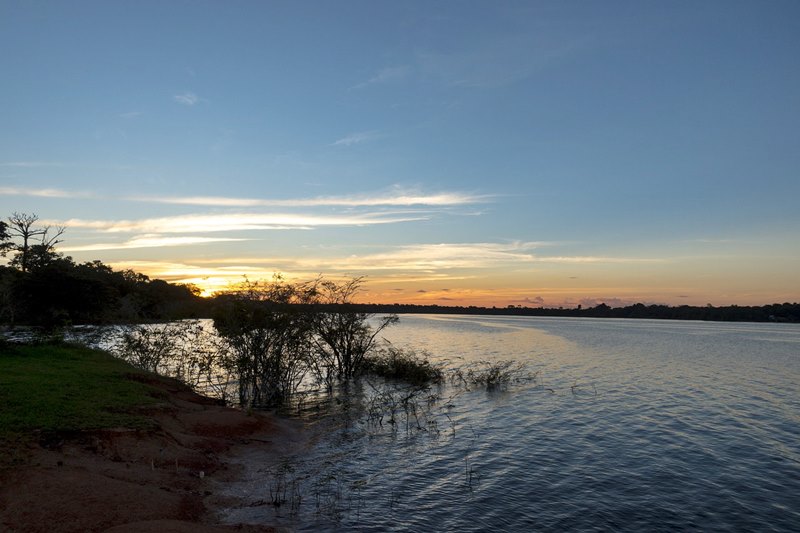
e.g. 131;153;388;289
103;241;660;305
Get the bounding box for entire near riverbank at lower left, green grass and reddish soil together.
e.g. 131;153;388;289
0;346;305;533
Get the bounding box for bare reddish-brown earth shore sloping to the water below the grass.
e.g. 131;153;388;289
0;383;306;533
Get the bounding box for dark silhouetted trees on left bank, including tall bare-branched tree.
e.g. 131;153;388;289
0;213;207;328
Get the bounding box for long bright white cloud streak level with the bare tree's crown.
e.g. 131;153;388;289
49;213;426;233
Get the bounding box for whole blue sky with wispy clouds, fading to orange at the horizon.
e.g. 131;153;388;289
0;0;800;307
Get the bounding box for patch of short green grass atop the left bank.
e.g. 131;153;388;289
0;344;170;442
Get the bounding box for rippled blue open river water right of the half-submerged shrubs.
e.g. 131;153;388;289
219;316;800;531
